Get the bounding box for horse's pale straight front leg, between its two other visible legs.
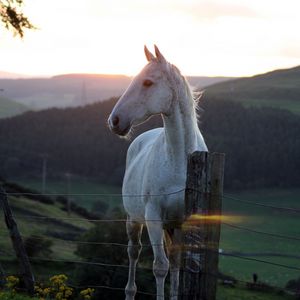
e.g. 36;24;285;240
146;215;169;300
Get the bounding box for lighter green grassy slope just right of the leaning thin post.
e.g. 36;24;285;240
0;192;92;259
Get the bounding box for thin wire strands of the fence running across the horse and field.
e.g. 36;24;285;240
0;188;300;297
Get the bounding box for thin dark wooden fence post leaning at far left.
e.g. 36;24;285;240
0;186;34;295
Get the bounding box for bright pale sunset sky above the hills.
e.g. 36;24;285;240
0;0;300;76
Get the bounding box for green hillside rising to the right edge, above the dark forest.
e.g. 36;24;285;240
206;66;300;114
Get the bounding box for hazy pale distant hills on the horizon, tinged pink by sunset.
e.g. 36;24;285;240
0;74;231;110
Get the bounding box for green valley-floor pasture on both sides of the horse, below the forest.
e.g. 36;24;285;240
9;180;300;287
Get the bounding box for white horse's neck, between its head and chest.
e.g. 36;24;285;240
163;81;200;161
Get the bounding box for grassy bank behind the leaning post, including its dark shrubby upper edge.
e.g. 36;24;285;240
0;179;95;260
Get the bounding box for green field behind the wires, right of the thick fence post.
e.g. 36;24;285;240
220;189;300;287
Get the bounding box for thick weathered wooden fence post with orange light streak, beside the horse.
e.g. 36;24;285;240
180;151;225;300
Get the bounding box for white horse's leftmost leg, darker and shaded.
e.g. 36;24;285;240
125;219;143;300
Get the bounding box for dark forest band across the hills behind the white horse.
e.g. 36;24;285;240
0;97;300;189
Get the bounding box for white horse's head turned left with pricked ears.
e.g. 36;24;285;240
108;46;173;136
